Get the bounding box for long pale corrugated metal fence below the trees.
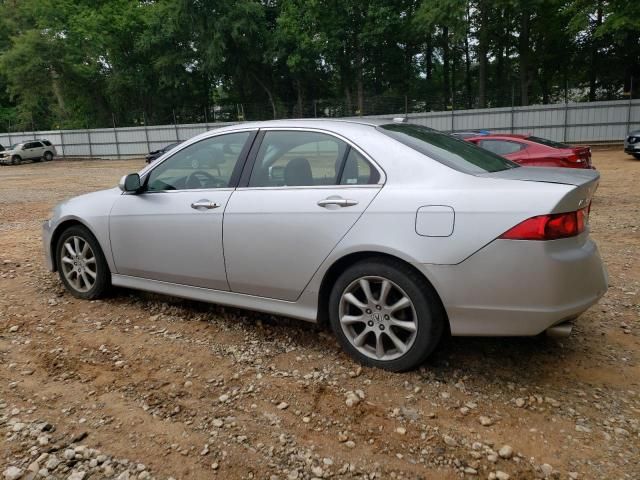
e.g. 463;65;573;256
0;100;640;158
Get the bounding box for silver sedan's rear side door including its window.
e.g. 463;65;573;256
224;129;383;301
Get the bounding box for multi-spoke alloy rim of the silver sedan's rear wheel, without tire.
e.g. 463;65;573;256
338;276;418;361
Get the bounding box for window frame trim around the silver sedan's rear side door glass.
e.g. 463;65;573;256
236;127;387;191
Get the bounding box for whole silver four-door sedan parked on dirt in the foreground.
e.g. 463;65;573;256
43;120;607;371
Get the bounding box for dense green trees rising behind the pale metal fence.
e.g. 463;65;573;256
0;0;640;130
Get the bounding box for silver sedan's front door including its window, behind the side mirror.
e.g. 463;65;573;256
109;131;255;290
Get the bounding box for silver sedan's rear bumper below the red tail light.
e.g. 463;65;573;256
423;233;608;336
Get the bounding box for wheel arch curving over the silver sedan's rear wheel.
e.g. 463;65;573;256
317;250;451;332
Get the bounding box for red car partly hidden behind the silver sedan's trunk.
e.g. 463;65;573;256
465;134;593;168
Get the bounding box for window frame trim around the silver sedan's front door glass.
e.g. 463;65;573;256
140;128;259;194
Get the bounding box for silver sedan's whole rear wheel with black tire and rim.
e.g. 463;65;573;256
329;258;446;372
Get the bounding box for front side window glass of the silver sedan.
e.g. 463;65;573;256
147;132;251;191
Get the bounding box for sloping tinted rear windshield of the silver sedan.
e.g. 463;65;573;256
378;123;519;174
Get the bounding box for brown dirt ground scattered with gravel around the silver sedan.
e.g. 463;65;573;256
0;150;640;480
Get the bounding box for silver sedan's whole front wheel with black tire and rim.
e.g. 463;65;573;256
55;225;111;300
